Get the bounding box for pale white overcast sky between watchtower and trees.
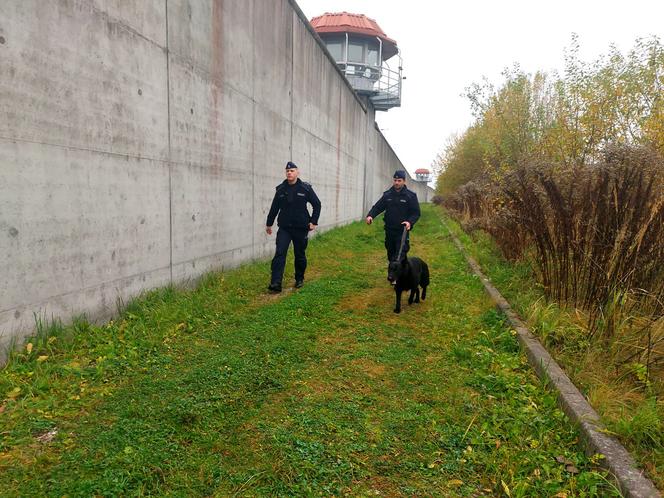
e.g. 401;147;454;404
296;0;664;173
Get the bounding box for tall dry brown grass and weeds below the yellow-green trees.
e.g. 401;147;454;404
443;146;664;372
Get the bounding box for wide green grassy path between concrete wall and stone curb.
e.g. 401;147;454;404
0;207;615;497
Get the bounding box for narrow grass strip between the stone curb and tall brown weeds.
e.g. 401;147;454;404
439;207;664;490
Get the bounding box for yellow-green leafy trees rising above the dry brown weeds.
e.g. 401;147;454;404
436;37;664;195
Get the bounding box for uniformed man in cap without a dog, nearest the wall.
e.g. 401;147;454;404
265;161;320;292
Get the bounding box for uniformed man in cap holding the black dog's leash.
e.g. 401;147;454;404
367;170;420;261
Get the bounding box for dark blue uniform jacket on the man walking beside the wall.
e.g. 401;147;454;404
265;178;320;228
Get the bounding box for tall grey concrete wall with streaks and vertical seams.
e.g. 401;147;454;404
0;0;428;352
